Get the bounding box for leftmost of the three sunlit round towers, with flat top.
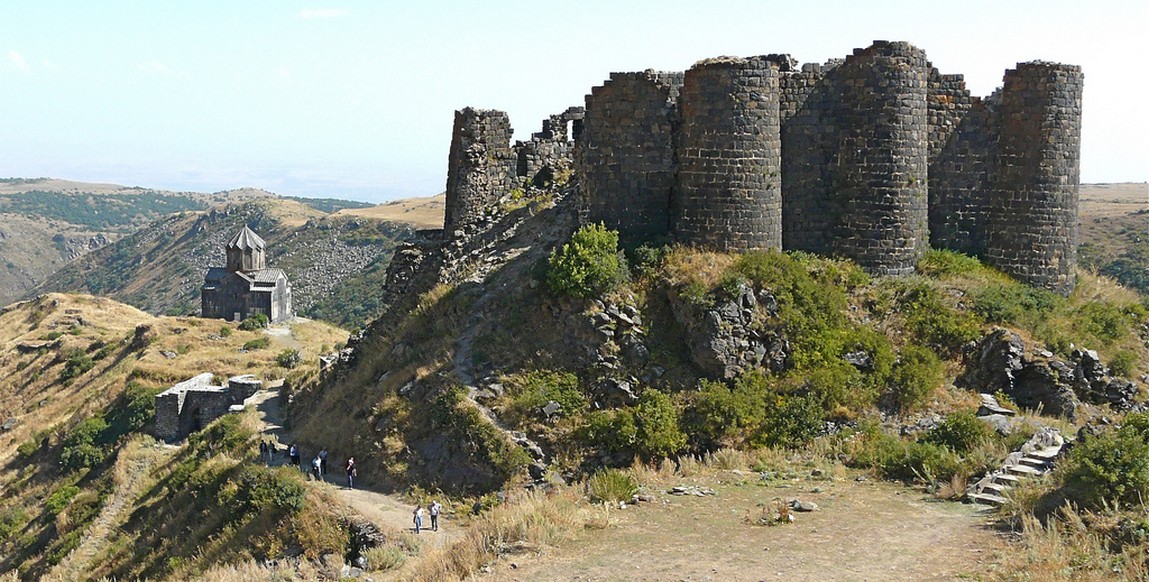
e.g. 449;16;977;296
673;56;781;250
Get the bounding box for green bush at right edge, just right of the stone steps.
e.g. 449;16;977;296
1062;413;1149;509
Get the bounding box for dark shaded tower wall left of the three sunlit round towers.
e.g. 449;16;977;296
575;71;683;241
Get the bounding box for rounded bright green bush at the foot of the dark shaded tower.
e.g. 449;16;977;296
547;224;626;297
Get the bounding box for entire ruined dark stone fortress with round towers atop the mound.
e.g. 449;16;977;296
444;41;1084;294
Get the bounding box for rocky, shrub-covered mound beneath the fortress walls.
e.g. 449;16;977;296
282;180;1149;580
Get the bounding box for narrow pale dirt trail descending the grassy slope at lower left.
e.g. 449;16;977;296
45;445;175;581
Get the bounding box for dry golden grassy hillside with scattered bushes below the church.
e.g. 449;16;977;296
0;294;347;580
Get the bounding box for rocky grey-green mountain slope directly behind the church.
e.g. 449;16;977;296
31;197;410;326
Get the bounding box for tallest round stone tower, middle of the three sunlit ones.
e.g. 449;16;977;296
831;40;930;276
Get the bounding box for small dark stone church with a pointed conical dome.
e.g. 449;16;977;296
200;226;294;324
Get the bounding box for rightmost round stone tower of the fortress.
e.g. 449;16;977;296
986;61;1084;295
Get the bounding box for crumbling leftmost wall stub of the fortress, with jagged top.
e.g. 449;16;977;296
444;107;515;235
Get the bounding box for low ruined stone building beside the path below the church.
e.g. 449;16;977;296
155;372;262;442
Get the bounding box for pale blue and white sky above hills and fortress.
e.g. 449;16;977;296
0;0;1149;202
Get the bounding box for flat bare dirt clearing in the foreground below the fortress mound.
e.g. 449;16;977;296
485;472;1002;582
